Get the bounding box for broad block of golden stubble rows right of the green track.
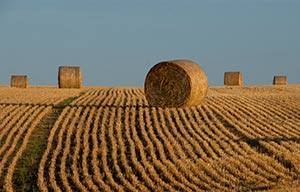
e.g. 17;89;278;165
38;88;300;191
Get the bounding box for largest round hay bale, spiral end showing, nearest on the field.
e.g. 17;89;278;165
145;60;208;108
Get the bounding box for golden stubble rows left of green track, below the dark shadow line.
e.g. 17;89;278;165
0;105;51;191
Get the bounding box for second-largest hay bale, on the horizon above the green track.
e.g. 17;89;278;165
58;66;82;89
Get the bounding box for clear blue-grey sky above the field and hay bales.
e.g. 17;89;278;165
0;0;300;86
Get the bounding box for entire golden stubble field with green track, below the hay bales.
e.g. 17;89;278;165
0;85;300;191
